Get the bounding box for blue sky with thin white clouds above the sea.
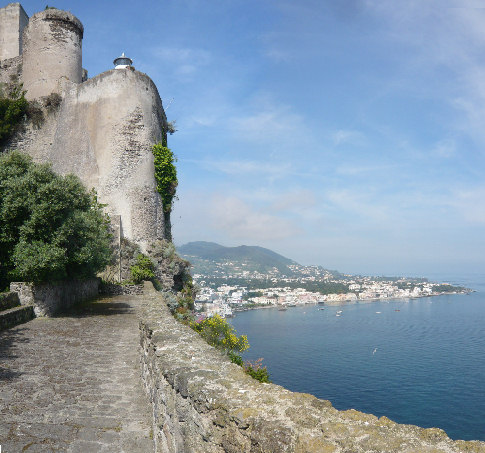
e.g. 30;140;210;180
17;0;485;275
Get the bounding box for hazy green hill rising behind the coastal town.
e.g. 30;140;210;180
177;241;298;275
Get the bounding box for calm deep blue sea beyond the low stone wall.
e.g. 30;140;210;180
231;275;485;440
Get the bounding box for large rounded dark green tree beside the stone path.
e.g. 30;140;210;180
0;151;111;290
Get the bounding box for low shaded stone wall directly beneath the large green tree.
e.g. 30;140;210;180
10;278;99;316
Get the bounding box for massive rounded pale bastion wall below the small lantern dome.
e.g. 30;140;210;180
10;69;166;250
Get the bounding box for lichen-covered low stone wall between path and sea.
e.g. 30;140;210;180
140;283;485;453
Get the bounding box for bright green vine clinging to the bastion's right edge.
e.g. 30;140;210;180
152;143;178;213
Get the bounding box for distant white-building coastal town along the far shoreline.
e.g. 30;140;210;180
193;261;470;317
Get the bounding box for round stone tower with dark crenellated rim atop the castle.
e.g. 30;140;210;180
22;9;84;99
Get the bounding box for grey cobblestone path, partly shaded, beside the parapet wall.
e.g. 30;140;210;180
0;296;153;453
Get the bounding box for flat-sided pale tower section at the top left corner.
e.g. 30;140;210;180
0;3;29;60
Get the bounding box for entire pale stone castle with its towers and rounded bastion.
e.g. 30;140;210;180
0;3;170;268
